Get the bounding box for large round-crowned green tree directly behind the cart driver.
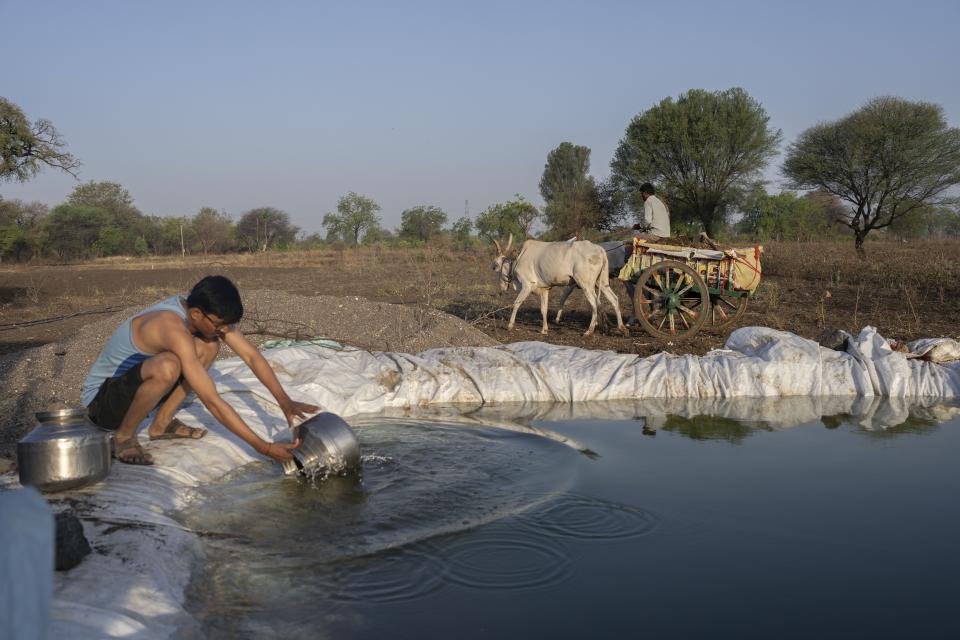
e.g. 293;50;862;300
610;88;780;235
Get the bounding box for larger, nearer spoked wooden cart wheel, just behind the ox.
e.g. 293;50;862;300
633;260;710;339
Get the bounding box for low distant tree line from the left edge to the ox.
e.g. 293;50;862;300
0;182;496;262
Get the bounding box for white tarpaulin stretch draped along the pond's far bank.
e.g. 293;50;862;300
215;327;960;415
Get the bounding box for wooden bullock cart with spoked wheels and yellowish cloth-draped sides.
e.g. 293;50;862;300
618;238;763;339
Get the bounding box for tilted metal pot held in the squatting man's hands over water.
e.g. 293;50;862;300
283;412;360;478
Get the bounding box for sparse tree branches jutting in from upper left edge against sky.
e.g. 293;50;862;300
0;97;80;182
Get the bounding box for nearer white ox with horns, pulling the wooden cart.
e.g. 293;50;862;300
493;235;628;336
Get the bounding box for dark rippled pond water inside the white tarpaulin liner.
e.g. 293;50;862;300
180;398;960;639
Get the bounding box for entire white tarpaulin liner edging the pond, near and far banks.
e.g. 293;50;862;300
9;327;960;639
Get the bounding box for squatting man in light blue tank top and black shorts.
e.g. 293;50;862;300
81;276;319;464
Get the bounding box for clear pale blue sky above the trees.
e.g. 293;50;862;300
0;0;960;232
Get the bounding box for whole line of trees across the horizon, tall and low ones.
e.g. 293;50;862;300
0;88;960;261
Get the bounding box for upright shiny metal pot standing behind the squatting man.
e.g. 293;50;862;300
17;409;112;492
